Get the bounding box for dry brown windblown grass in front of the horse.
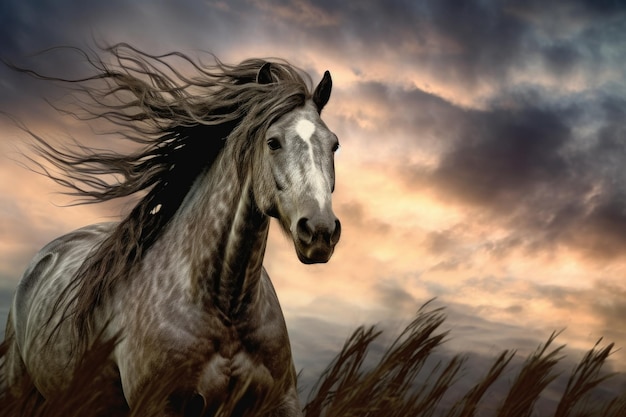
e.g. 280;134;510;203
0;305;626;417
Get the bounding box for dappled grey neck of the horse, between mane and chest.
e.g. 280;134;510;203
165;147;269;318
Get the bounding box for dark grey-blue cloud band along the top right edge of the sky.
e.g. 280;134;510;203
247;0;626;87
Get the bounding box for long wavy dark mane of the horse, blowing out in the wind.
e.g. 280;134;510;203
20;44;311;347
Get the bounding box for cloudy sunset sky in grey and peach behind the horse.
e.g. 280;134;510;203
0;0;626;404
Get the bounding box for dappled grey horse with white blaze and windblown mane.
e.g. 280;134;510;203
5;44;341;417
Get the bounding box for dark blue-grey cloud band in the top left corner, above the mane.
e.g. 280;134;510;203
0;0;227;57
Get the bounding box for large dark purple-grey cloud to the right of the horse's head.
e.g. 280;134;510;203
354;74;626;257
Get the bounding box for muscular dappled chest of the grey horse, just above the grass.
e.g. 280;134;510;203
118;296;292;406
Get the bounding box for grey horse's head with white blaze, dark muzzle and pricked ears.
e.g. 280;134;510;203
253;64;341;264
